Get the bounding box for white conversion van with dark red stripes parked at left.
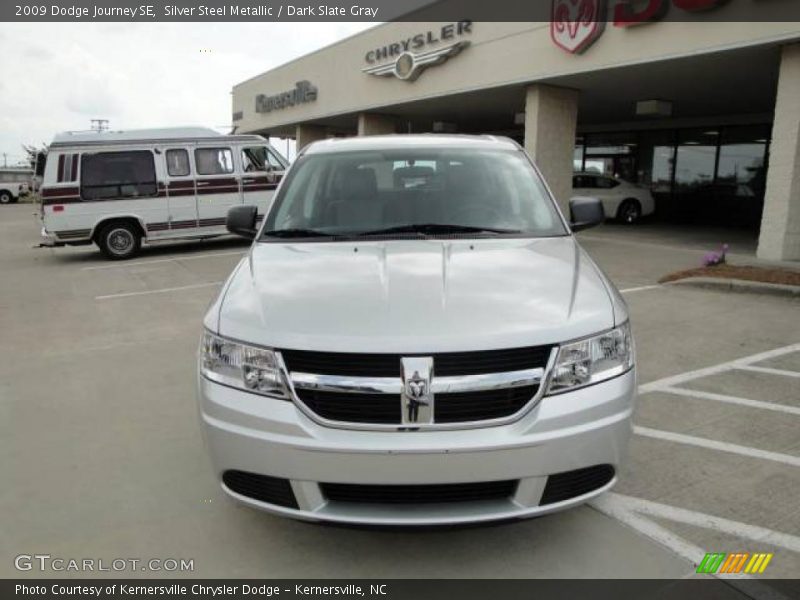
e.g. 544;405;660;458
41;127;287;260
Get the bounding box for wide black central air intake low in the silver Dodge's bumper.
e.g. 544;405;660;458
320;480;517;504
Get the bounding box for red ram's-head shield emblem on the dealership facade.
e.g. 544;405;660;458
550;0;608;54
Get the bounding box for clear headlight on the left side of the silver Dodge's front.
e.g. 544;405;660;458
200;331;290;400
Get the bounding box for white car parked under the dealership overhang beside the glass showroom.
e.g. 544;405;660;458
572;172;656;224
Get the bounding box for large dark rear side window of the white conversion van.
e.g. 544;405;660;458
81;150;156;200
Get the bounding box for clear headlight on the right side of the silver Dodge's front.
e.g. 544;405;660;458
547;323;633;394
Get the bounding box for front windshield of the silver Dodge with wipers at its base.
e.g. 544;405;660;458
262;148;567;240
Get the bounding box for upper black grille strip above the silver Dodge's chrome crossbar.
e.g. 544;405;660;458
281;346;551;377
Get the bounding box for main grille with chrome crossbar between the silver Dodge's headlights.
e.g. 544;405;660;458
281;346;553;429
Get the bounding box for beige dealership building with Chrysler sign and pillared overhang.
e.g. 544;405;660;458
233;9;800;260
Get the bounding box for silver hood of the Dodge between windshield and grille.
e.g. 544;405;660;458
218;236;614;353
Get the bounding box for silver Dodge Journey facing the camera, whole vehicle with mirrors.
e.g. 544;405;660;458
198;135;636;525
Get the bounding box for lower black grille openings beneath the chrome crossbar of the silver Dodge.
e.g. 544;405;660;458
296;385;538;425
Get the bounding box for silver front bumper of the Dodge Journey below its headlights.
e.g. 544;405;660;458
198;370;636;525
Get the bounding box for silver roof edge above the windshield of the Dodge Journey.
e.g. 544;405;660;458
301;133;520;154
